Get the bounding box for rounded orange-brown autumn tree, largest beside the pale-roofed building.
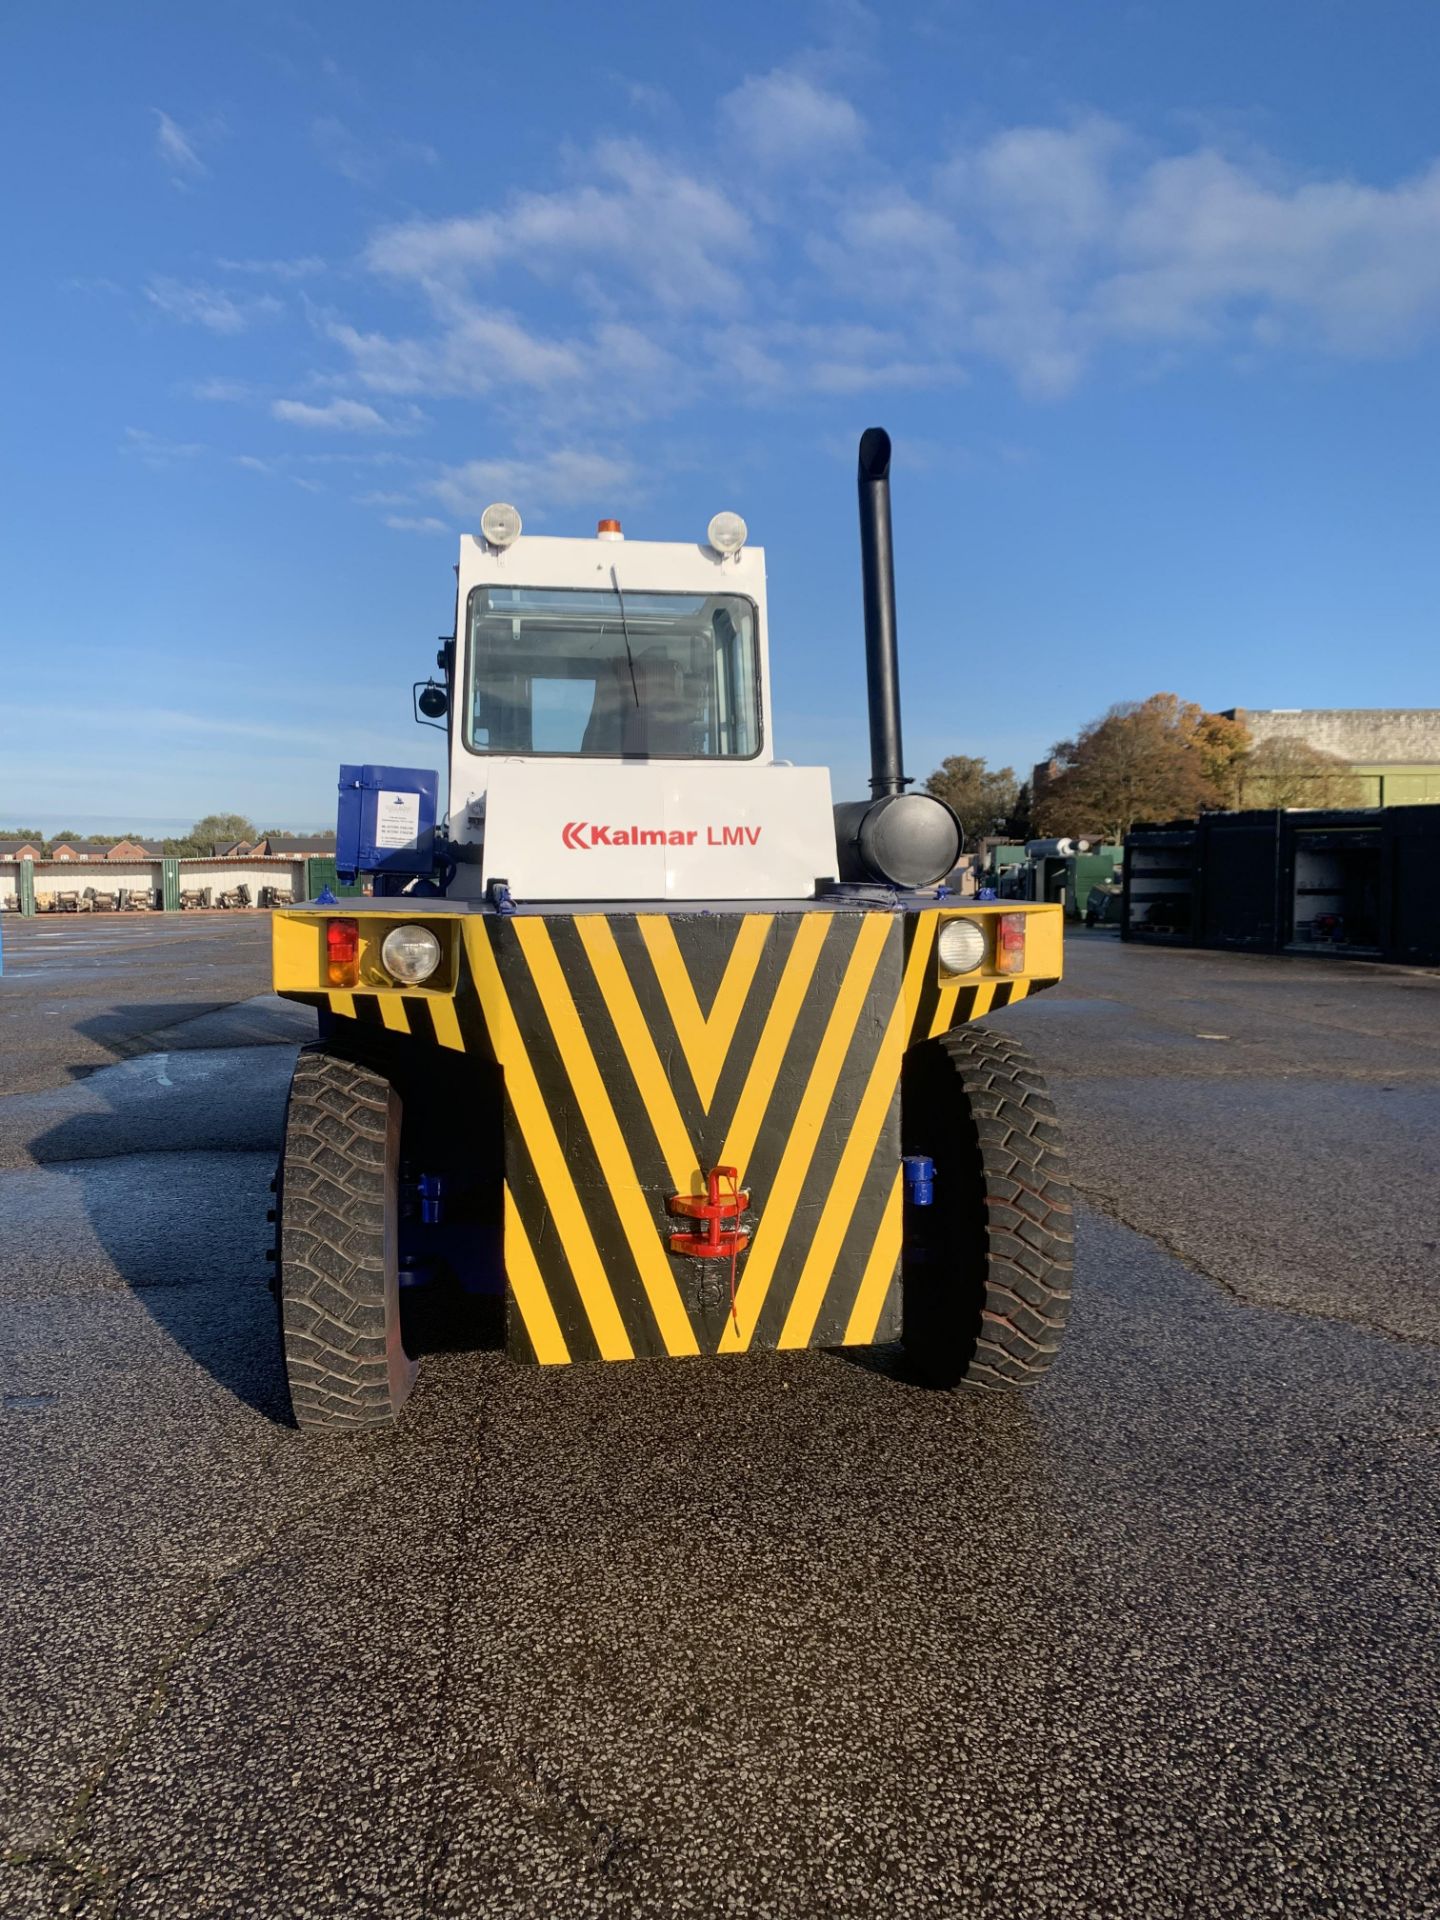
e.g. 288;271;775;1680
1035;693;1225;841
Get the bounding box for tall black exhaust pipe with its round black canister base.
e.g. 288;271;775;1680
835;426;964;887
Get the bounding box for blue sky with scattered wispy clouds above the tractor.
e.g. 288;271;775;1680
0;0;1440;829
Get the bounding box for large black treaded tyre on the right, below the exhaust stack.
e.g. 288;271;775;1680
902;1027;1075;1392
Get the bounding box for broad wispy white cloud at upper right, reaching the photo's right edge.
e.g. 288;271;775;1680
810;119;1440;396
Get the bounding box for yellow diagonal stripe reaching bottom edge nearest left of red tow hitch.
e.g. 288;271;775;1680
515;918;699;1356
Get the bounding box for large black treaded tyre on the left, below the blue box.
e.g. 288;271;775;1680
276;1046;415;1432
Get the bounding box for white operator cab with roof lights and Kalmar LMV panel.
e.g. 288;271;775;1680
449;507;835;900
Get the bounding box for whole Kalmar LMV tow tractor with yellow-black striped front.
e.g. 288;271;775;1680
273;428;1071;1428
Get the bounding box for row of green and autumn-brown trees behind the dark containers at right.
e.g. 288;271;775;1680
925;693;1363;843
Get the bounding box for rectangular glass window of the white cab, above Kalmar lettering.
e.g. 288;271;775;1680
465;586;760;760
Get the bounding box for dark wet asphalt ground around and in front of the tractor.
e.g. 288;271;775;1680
0;916;1440;1920
